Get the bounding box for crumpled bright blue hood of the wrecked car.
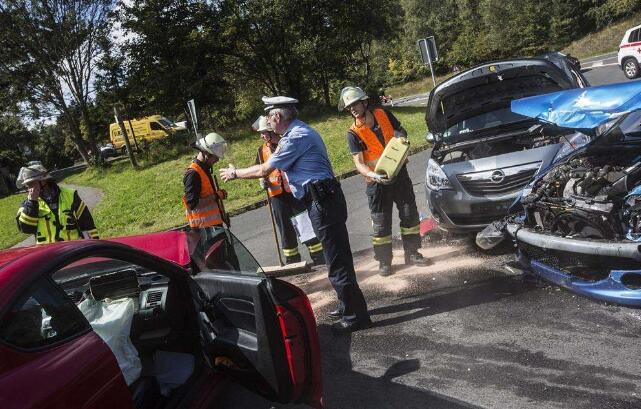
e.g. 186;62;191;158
511;81;641;129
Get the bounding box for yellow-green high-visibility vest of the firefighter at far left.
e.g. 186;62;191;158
36;187;85;244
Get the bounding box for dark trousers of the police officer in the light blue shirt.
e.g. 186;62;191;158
305;182;369;322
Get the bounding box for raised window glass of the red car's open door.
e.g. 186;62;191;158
187;226;264;276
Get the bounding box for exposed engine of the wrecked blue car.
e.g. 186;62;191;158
521;151;641;240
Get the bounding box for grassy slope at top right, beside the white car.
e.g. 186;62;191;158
562;13;641;58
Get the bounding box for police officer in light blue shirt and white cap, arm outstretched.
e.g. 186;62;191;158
220;97;372;331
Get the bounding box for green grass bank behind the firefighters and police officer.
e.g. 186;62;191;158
60;108;426;241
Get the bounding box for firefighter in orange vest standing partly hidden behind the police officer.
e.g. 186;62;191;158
252;116;325;265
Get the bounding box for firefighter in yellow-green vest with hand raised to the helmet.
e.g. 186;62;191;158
16;164;98;244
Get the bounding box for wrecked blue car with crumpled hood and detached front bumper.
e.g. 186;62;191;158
477;81;641;307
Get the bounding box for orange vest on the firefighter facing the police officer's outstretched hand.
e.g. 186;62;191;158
183;161;223;228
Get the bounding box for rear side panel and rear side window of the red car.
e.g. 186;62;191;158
0;278;132;409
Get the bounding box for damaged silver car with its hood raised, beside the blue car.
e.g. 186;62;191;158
425;59;589;233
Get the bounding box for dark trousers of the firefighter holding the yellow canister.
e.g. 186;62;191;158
366;166;421;264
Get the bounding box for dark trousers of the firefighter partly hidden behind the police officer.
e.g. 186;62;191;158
271;192;322;261
